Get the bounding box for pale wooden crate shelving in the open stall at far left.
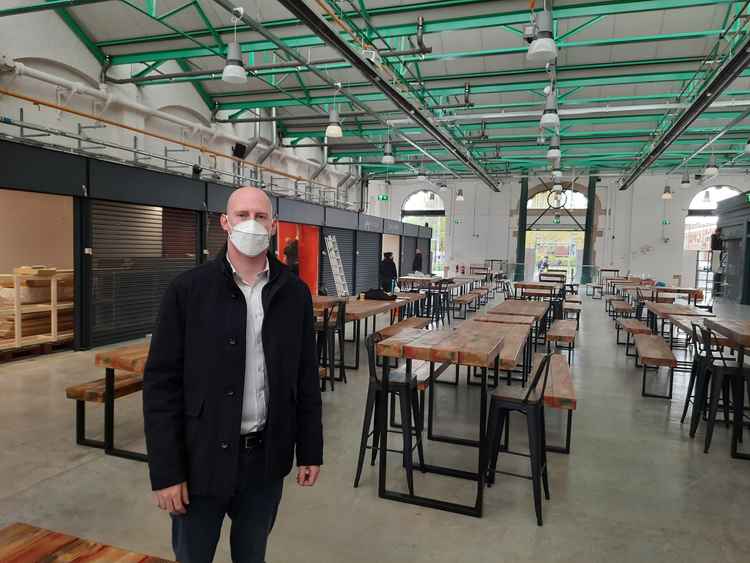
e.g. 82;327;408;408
0;266;73;351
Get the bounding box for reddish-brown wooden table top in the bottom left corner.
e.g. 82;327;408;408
0;523;168;563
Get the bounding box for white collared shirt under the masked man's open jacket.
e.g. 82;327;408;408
227;255;269;434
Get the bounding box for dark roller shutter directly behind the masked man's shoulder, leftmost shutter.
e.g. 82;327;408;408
91;200;198;346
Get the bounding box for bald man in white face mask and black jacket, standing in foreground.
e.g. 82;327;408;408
143;188;323;563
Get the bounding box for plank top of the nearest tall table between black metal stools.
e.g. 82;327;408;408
377;321;506;367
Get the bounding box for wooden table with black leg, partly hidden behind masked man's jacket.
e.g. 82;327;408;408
94;342;150;461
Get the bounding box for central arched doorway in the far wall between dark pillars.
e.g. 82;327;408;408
524;185;588;281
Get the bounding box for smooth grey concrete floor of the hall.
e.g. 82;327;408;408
0;298;750;563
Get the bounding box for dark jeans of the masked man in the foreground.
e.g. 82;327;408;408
172;447;284;563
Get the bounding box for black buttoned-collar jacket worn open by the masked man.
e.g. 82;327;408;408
143;247;323;497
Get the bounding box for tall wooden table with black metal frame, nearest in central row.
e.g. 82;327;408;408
376;321;508;517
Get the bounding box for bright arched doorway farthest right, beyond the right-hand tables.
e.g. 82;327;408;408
684;186;740;303
